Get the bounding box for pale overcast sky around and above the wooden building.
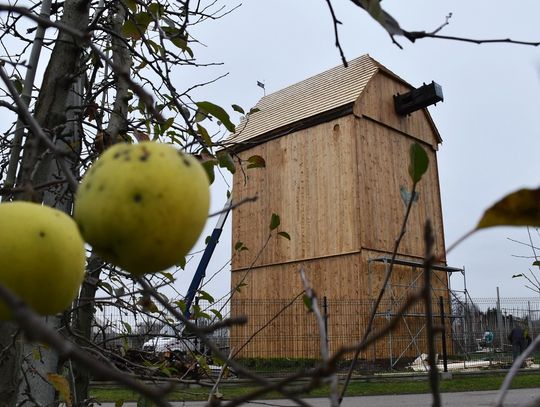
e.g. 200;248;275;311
174;0;540;297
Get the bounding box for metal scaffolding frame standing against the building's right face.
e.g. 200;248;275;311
368;255;468;369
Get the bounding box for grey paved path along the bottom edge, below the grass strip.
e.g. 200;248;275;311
98;388;540;407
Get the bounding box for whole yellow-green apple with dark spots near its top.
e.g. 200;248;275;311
74;141;210;276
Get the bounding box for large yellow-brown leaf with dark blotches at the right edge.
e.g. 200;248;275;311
476;188;540;229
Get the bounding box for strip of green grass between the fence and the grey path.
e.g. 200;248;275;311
91;374;540;402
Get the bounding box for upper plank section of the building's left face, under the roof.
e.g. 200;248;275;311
232;116;359;274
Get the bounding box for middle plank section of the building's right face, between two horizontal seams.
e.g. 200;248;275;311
357;118;444;258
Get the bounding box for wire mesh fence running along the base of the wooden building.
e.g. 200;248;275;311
93;296;540;375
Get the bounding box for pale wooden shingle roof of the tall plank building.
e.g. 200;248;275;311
226;54;440;151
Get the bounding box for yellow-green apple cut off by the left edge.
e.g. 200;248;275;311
0;202;85;319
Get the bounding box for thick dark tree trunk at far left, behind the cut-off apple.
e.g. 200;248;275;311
4;0;90;405
